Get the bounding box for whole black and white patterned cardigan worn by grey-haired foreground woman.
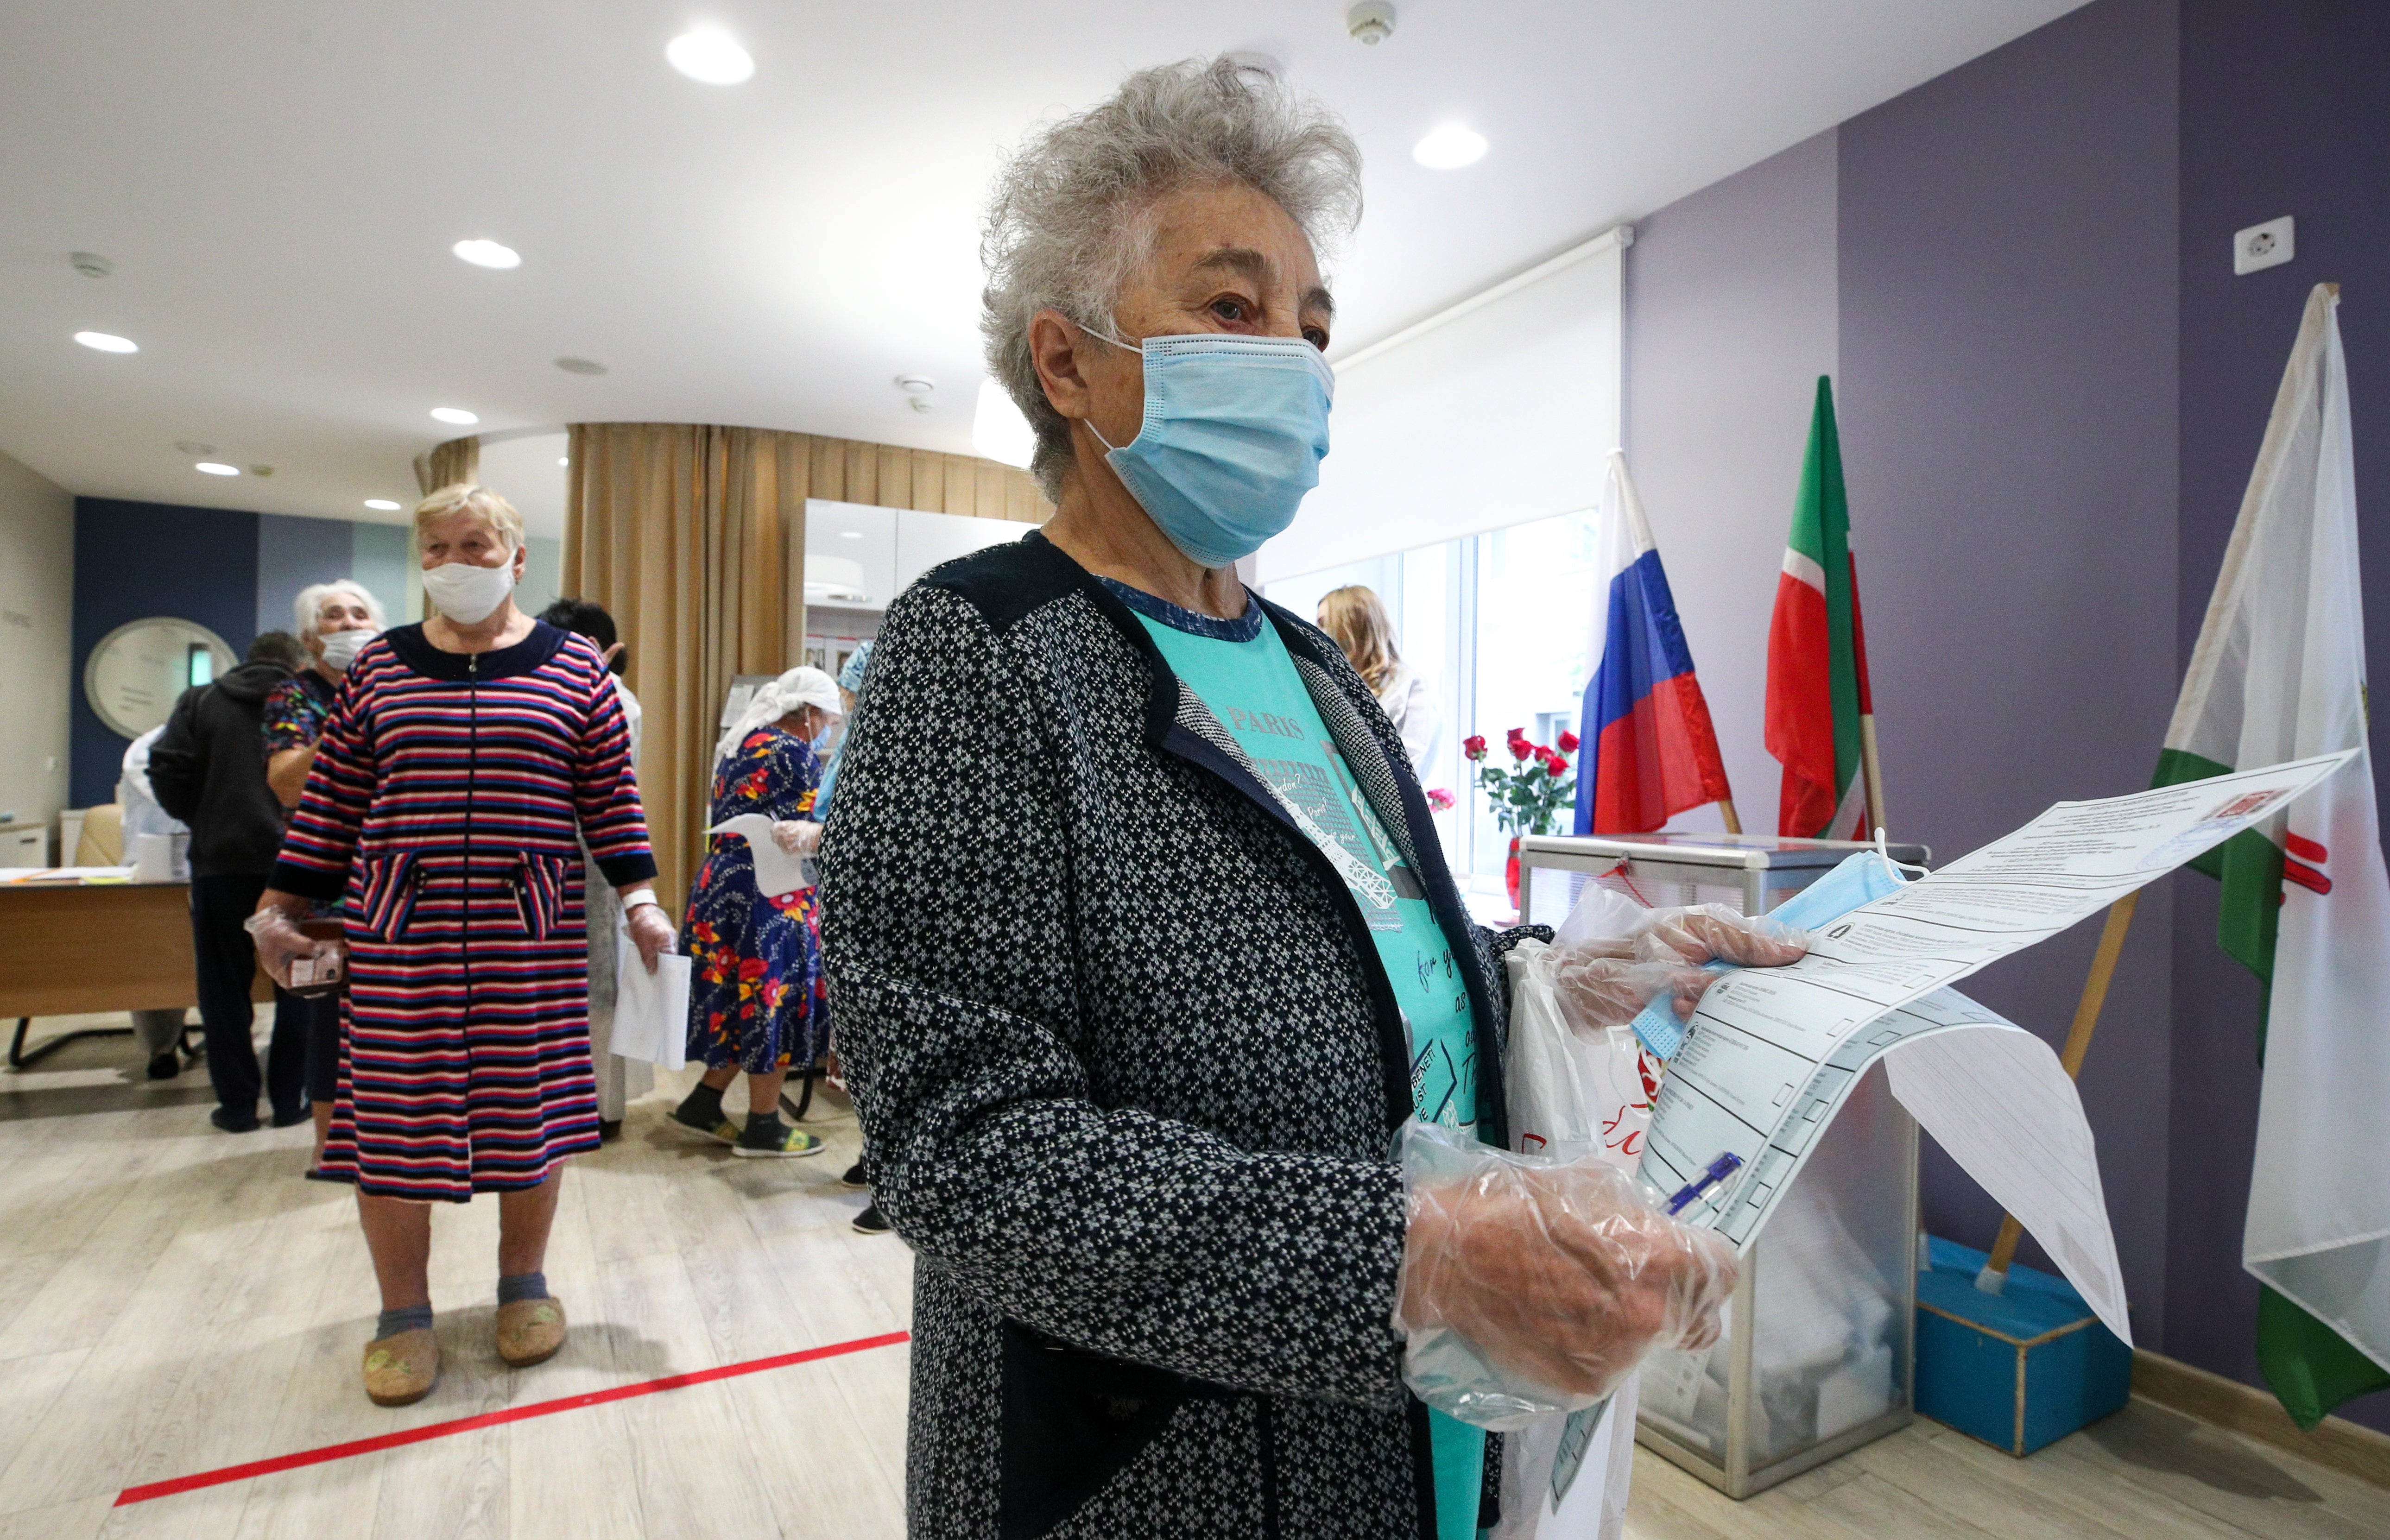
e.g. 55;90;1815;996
822;533;1515;1540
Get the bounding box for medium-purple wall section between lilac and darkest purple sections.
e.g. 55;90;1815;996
1835;0;2177;1344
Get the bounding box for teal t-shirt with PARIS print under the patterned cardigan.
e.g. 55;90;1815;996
1106;581;1484;1540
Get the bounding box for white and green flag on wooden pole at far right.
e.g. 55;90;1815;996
2158;284;2390;1427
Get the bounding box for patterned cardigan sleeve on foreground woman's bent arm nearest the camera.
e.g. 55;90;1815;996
822;586;1405;1406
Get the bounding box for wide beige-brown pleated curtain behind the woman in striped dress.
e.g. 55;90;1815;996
564;423;1052;914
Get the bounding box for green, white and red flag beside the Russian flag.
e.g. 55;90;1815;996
1766;375;1876;839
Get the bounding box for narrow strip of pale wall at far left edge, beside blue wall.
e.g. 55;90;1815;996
0;454;79;856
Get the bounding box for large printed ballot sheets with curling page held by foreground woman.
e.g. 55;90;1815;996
1639;751;2354;1342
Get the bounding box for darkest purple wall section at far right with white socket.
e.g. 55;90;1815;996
2165;0;2390;1433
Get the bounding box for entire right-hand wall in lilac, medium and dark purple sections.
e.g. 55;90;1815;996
1628;0;2390;1430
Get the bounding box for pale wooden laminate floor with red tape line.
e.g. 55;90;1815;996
0;1019;2390;1540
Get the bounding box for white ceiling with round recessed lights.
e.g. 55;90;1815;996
0;0;2079;519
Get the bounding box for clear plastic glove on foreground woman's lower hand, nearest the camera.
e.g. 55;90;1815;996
1393;1122;1738;1430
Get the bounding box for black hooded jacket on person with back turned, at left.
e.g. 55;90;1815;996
151;663;291;877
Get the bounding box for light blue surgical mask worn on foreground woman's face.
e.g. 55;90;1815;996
1088;332;1336;567
